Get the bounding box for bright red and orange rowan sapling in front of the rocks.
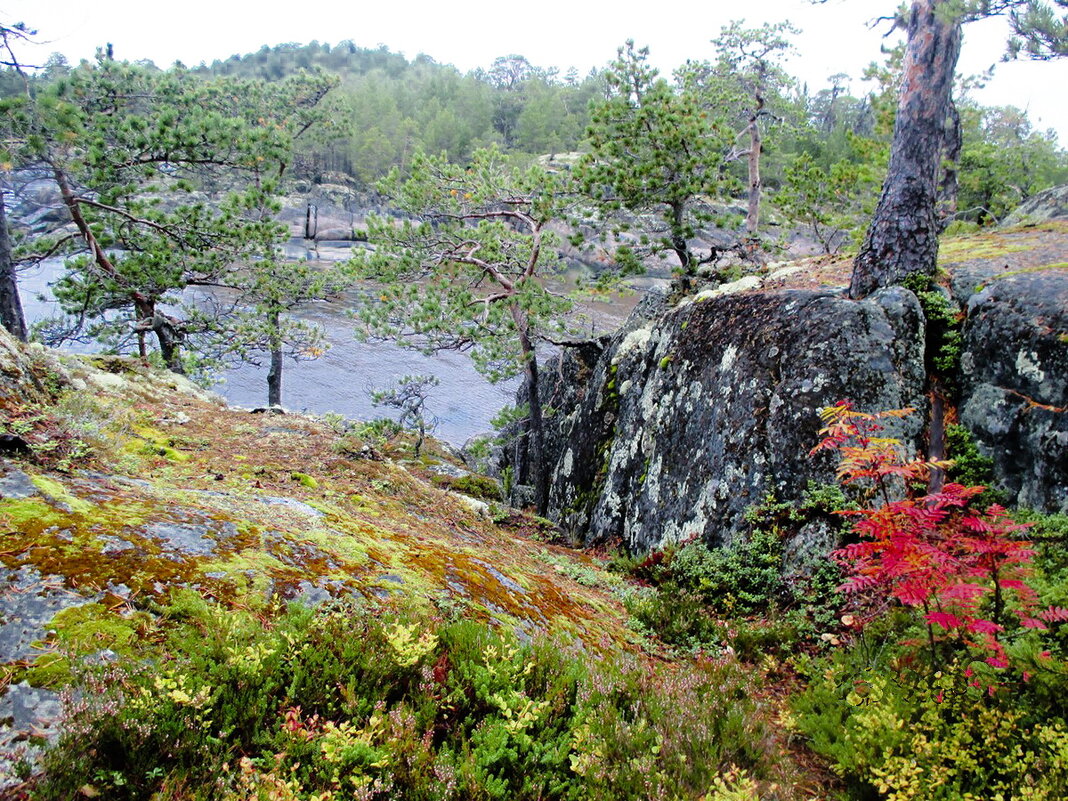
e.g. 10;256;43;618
813;401;1055;668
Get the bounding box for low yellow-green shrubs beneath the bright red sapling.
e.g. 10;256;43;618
794;656;1068;801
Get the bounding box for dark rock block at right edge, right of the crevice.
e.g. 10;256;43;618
960;270;1068;512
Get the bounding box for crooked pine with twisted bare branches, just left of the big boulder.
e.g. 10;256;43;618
359;147;571;514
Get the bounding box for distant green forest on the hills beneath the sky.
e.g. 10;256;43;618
0;42;1068;228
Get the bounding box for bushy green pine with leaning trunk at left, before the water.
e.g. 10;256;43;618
8;58;333;371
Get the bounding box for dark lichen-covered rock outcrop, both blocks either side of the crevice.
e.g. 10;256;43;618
502;241;1068;551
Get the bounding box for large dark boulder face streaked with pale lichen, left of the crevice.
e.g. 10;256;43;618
505;288;925;551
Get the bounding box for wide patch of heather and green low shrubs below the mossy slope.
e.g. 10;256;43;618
33;591;780;801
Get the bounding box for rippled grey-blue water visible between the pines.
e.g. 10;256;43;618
19;240;633;445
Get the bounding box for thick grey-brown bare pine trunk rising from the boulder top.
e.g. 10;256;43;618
849;0;961;298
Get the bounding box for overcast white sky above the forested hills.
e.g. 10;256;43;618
0;0;1068;139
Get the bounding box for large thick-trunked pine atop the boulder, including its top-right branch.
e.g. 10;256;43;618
841;0;1068;298
